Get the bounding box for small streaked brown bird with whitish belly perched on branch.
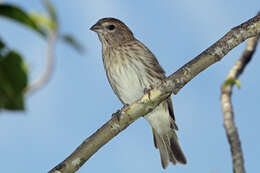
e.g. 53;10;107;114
90;18;186;169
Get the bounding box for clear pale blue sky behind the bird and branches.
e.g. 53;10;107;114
0;0;260;173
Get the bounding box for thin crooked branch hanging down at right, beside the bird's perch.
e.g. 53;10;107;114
221;28;260;173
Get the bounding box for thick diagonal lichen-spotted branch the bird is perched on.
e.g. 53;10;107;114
49;12;260;173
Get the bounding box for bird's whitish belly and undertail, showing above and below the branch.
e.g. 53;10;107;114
107;58;170;134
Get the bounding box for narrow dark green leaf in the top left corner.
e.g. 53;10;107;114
0;4;46;37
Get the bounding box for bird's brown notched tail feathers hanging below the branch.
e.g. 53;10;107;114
153;129;187;169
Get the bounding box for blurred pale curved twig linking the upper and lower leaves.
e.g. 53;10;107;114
25;32;57;95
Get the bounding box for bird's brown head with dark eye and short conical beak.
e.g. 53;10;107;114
90;18;134;46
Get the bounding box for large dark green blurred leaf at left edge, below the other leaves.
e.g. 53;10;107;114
0;46;28;110
